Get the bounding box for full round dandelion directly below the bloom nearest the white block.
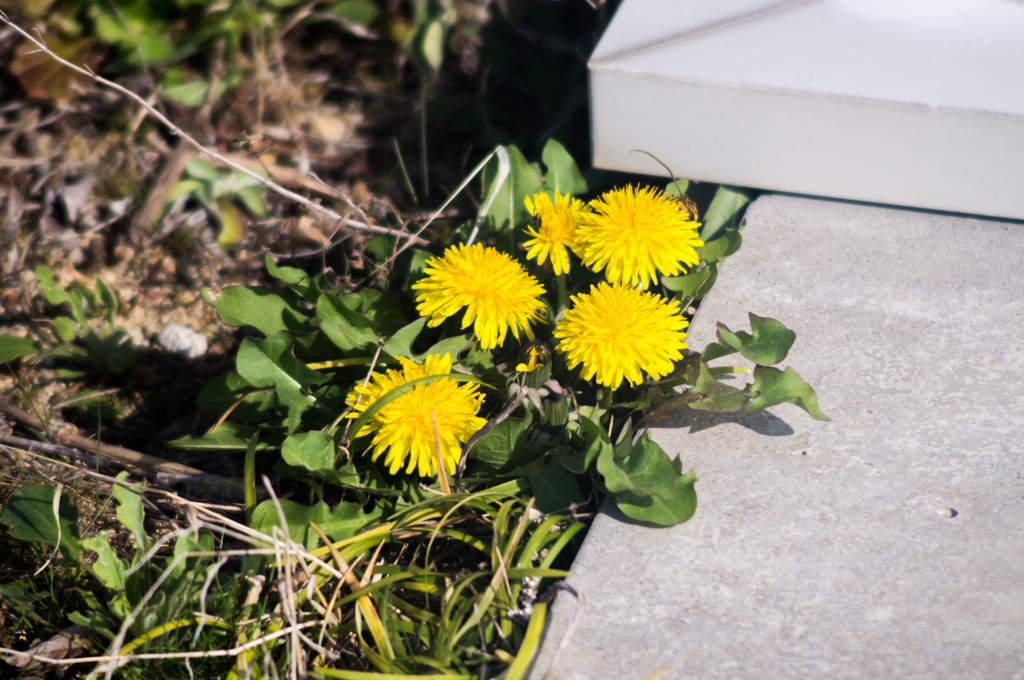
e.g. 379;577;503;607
554;283;689;389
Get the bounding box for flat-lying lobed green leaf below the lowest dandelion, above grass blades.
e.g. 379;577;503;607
252;500;383;550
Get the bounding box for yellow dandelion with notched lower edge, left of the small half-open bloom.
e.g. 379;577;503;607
413;244;544;349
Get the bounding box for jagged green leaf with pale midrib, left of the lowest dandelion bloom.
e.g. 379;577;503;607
237;333;331;434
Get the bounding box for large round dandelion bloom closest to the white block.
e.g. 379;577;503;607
575;186;703;288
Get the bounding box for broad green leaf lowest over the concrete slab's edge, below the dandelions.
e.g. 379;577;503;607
597;432;697;526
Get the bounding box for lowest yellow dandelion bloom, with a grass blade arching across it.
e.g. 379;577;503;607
345;354;487;477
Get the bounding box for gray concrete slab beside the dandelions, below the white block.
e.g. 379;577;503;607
531;196;1024;680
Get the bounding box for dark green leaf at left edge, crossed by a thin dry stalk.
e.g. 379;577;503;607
0;484;82;561
